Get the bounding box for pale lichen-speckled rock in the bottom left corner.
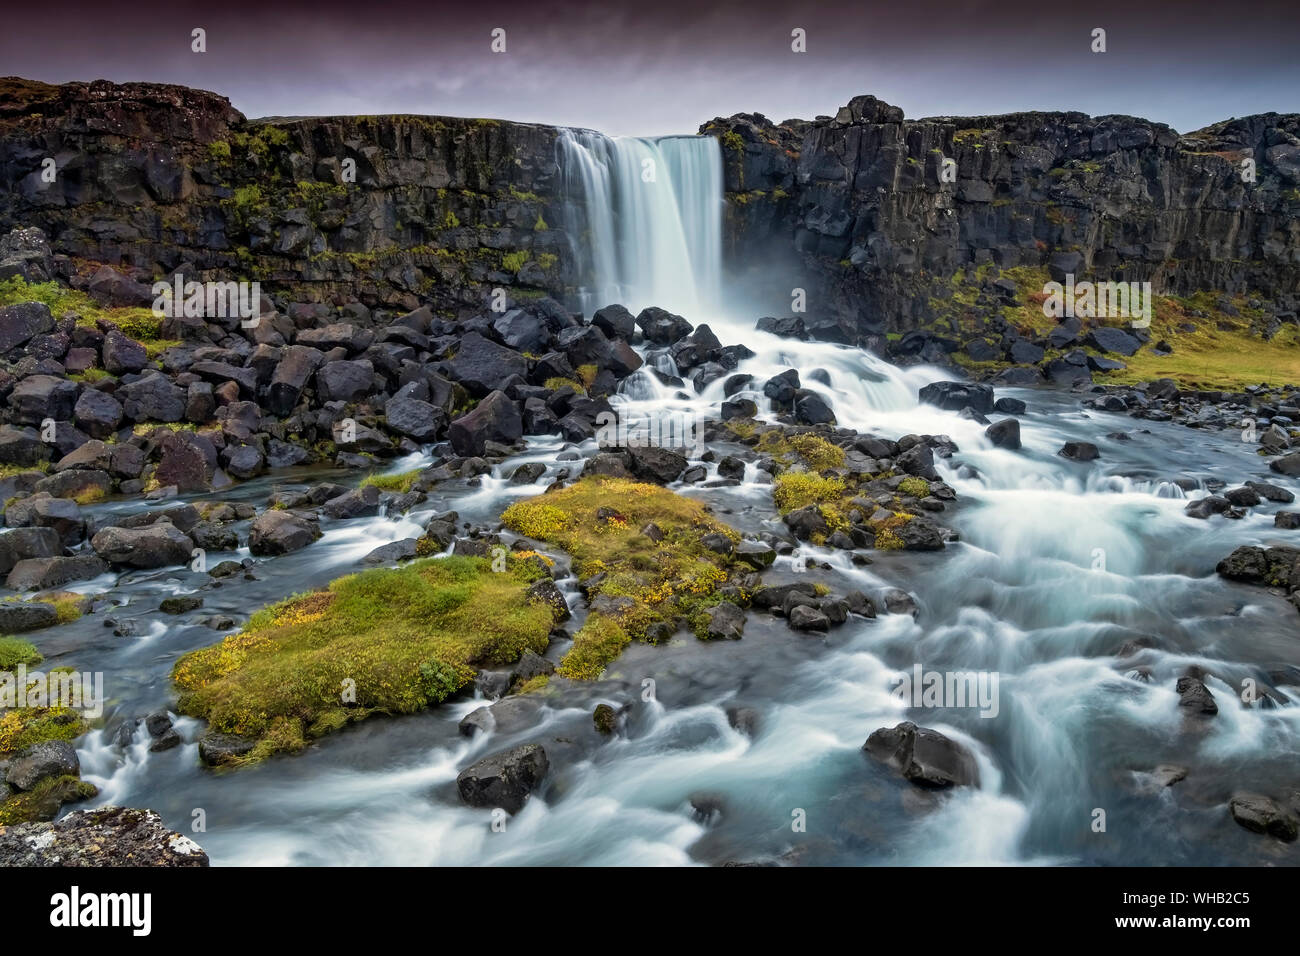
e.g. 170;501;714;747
0;806;208;866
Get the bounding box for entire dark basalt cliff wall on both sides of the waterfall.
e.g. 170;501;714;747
0;78;1300;343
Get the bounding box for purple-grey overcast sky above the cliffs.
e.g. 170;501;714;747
0;0;1300;135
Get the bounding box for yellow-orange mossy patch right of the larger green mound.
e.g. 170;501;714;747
501;477;740;680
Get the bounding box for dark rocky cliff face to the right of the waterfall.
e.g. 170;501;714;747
701;96;1300;341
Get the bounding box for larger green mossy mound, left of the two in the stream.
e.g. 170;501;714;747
172;557;553;762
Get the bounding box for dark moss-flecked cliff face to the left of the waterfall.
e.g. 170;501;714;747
0;78;572;312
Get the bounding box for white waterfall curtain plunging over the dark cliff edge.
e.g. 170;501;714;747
556;130;723;315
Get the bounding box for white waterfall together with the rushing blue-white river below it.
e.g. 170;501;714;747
71;133;1300;865
